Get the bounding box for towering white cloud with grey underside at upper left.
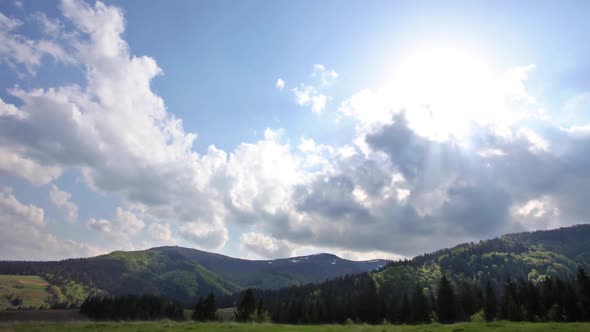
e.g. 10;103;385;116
0;0;234;250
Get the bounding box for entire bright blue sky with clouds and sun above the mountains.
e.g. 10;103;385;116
0;0;590;260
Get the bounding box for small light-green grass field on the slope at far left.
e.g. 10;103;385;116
0;275;51;310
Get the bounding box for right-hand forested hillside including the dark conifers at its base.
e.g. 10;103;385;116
239;225;590;323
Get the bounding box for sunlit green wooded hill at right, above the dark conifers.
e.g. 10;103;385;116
380;225;590;289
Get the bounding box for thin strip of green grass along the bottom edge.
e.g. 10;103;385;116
0;321;590;332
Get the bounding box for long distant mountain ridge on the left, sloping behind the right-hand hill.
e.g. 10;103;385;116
0;247;388;304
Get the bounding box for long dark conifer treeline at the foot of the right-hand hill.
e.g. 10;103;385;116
241;268;590;324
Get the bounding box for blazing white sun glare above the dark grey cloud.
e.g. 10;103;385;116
388;47;502;140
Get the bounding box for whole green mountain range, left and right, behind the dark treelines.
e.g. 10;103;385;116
0;225;590;304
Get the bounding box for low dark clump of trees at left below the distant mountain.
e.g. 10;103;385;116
80;294;184;320
